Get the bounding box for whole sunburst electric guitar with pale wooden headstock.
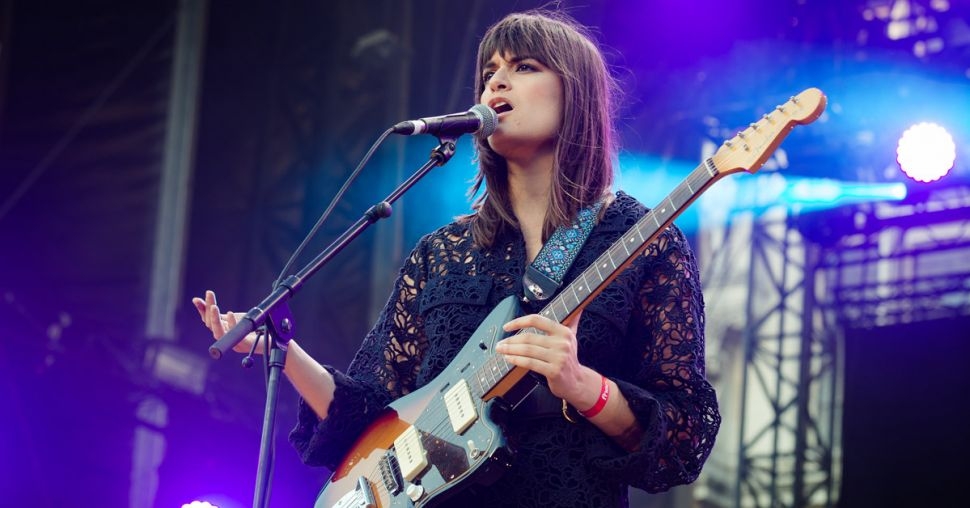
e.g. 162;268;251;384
315;88;826;508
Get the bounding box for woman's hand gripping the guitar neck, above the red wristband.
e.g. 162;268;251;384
495;314;600;408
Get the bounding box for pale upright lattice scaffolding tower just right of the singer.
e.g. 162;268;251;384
697;175;842;507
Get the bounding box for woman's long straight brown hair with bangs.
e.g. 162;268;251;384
466;10;617;247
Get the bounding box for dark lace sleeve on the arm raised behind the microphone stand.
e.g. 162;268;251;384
290;241;426;470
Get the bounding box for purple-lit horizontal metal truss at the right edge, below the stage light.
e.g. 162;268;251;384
820;186;970;328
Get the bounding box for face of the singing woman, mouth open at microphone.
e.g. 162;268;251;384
480;53;563;162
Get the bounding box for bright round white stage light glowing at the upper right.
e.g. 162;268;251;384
896;122;956;182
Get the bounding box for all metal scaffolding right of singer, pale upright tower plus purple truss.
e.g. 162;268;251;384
696;173;970;507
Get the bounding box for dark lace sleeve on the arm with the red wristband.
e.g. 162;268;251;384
588;227;720;492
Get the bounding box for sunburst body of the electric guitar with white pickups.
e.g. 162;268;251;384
314;297;520;508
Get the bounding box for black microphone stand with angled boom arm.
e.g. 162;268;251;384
209;136;457;508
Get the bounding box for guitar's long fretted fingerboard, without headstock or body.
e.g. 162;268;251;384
475;159;723;397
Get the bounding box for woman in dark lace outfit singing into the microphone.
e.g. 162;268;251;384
193;10;720;508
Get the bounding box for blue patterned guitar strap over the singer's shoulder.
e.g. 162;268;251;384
522;200;603;302
